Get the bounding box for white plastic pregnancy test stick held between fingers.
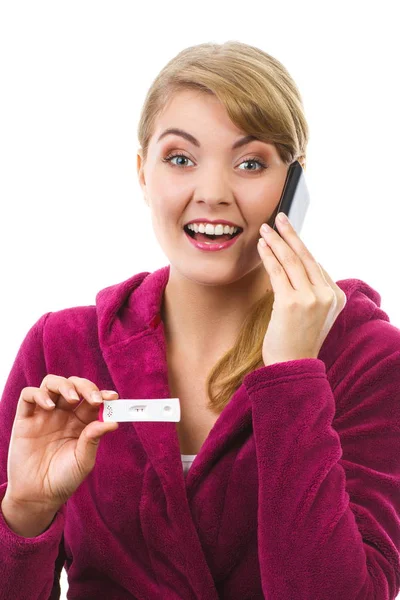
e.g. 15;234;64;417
99;398;181;423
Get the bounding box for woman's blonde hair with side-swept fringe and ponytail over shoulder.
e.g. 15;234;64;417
138;41;309;414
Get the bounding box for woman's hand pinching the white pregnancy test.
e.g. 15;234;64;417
6;375;118;513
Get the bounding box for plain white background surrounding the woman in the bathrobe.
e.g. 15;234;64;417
0;0;400;598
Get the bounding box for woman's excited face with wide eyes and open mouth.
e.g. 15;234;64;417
137;90;288;285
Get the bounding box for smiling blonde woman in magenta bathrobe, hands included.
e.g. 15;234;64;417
0;42;400;600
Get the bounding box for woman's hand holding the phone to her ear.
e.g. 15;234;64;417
257;213;346;366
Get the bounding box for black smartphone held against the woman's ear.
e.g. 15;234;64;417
268;160;310;235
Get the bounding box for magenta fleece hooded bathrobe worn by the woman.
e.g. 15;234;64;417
0;266;400;600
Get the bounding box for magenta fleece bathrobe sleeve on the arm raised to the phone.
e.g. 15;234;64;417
244;321;400;600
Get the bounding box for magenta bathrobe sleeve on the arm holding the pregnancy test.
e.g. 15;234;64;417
0;313;65;600
